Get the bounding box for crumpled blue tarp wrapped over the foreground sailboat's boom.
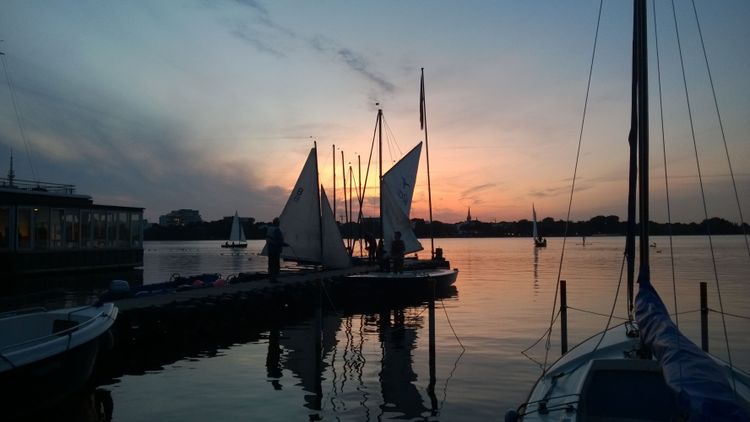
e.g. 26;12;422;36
635;268;750;421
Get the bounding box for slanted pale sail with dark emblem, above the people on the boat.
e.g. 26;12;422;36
380;142;423;254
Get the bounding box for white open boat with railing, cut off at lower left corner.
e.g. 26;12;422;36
0;303;118;413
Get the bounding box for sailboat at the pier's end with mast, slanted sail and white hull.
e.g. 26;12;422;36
347;105;458;289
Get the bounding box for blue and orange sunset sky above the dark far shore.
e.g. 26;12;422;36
0;0;750;222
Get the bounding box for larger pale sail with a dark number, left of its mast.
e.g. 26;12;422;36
279;148;321;262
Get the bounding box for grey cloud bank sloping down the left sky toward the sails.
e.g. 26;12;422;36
0;63;286;220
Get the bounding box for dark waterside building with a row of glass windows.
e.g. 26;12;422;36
0;178;143;278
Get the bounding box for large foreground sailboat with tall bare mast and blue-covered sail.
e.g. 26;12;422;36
505;0;750;421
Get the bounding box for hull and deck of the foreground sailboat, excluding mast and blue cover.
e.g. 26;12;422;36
506;324;750;422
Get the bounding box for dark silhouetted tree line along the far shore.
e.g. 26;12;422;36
143;215;750;240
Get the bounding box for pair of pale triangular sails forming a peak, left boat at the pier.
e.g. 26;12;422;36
261;145;351;268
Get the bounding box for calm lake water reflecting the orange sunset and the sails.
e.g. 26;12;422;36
19;236;750;422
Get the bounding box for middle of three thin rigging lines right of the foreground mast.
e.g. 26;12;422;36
672;0;737;394
